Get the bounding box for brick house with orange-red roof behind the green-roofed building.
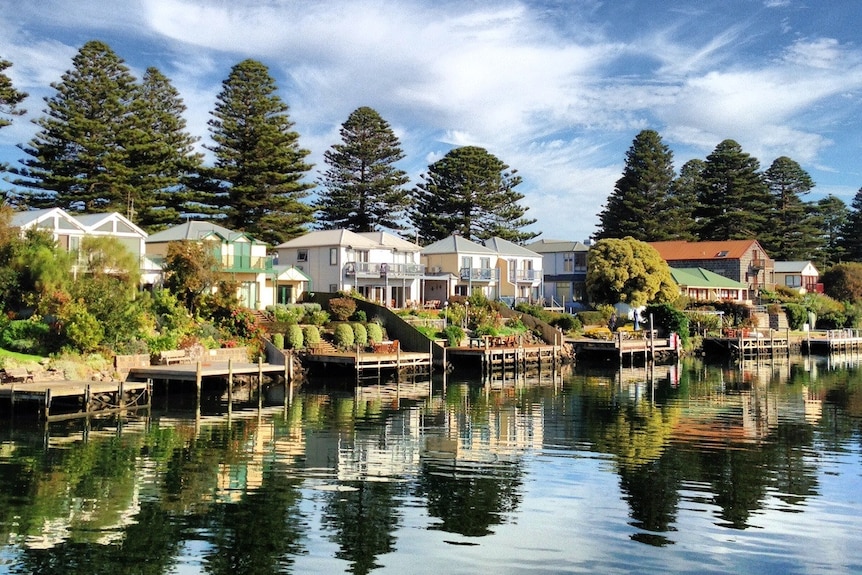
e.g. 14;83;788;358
649;240;775;299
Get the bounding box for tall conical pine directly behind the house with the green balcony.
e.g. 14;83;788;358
209;60;313;244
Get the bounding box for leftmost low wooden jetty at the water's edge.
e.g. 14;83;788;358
0;381;152;421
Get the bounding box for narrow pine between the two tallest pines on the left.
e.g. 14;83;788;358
126;68;202;232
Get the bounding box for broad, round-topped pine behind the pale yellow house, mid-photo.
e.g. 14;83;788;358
410;146;538;243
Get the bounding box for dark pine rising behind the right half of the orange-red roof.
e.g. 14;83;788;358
695;140;772;240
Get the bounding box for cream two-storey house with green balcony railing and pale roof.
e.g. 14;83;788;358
147;221;276;309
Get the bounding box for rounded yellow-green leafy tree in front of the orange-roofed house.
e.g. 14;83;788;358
586;237;679;307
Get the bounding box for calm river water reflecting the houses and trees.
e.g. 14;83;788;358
0;358;862;575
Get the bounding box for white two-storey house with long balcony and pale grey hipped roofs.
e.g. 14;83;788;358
276;229;423;307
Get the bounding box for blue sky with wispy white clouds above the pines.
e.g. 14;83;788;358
0;0;862;241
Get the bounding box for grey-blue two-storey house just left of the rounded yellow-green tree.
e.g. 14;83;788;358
526;240;590;312
